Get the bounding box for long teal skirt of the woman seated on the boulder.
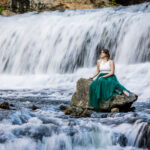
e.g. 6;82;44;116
89;73;130;108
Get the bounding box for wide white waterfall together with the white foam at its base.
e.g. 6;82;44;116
0;2;150;101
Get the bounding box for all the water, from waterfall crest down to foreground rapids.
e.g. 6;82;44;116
0;2;150;150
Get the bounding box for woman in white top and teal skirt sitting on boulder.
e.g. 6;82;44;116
88;49;131;108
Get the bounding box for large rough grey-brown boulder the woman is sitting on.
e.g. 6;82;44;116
65;78;138;116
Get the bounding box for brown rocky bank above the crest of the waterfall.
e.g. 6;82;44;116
0;0;143;16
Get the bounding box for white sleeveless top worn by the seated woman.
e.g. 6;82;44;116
99;60;111;73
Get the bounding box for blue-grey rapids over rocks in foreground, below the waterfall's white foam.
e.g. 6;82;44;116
0;90;150;150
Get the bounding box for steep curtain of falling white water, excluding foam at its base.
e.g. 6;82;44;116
0;3;150;75
